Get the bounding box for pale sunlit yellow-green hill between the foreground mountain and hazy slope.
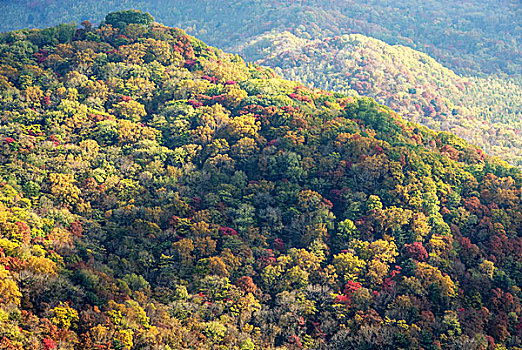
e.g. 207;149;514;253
238;32;522;166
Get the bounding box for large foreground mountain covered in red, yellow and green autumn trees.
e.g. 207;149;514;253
0;10;522;350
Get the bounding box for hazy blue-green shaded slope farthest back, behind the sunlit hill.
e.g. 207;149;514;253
0;0;522;75
